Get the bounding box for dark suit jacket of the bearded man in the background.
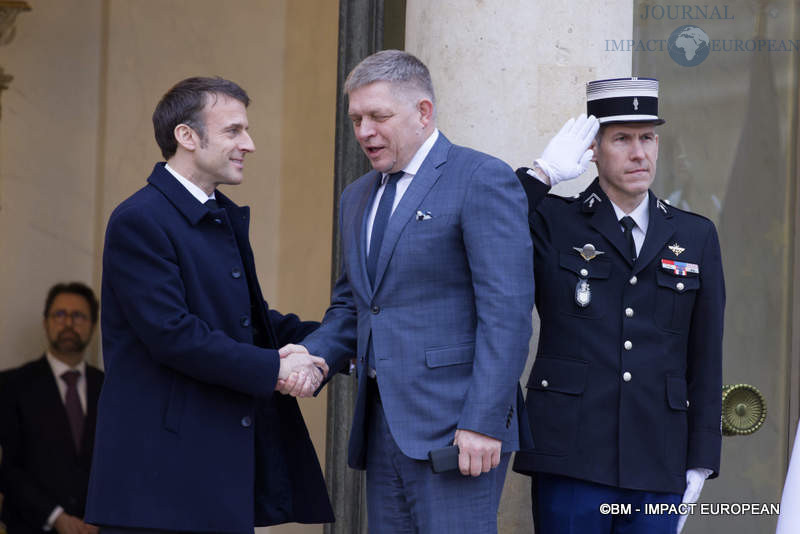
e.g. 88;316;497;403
0;356;103;534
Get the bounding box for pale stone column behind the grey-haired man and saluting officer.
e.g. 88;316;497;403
406;0;634;533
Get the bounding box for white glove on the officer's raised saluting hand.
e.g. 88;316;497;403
535;113;600;186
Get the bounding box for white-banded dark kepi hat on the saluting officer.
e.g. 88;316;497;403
586;76;666;125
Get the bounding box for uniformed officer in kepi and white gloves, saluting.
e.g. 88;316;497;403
514;78;725;534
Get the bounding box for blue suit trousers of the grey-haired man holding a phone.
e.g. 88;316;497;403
367;388;511;534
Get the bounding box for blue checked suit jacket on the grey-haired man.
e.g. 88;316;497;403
304;135;534;468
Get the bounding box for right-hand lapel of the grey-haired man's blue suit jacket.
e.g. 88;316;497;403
365;136;451;290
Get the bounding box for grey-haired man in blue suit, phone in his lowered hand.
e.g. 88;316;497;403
282;50;533;534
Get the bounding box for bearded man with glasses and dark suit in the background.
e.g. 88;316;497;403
0;282;103;534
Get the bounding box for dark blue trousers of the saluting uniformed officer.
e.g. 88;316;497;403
531;473;681;534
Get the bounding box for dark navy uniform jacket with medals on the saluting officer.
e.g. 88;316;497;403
514;176;725;493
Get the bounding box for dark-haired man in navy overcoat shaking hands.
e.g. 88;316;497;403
86;78;333;533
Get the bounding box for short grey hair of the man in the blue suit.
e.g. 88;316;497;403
344;50;435;103
